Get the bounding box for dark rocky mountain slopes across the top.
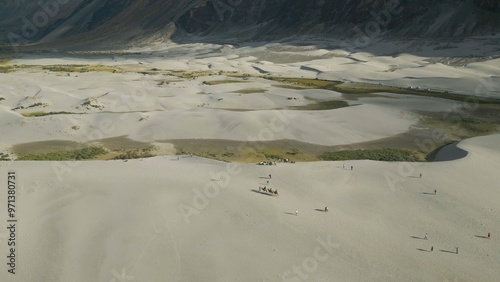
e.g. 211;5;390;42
0;0;500;48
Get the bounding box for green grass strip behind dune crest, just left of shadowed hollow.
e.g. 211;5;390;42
318;148;425;162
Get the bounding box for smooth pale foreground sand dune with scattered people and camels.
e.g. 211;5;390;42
0;135;500;281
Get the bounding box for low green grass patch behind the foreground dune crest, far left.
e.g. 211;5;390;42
18;147;107;161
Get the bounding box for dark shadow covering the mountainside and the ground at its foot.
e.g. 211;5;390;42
0;0;500;57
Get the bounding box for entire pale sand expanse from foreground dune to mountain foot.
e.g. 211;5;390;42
0;39;500;282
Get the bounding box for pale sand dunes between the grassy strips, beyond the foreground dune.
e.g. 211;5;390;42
0;71;418;146
